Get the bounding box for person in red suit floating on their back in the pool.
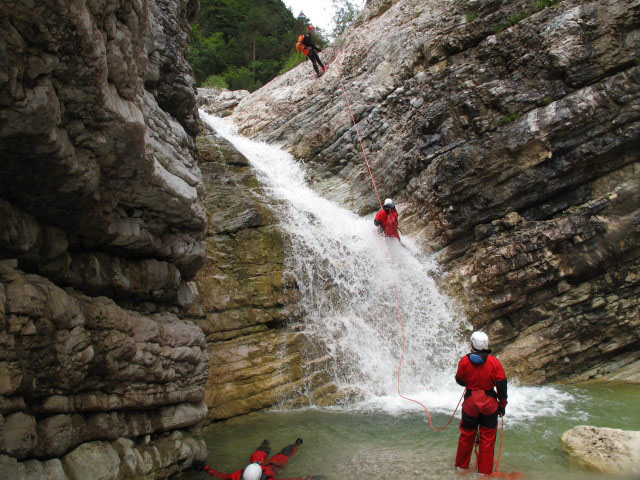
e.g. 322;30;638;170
193;438;325;480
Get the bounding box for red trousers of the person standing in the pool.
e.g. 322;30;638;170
456;390;498;474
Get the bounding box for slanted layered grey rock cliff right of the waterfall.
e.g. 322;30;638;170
228;0;640;382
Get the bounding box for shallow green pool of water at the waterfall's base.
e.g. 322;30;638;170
184;384;640;480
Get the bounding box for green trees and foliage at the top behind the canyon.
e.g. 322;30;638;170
189;0;327;91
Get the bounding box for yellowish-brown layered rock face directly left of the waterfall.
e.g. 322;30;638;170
189;122;336;420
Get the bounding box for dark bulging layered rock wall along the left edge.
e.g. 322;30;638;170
0;0;207;479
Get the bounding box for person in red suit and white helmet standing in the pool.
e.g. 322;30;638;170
455;332;507;475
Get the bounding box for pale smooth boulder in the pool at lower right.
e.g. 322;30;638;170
561;425;640;475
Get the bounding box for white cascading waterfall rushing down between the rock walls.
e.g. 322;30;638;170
200;111;571;418
